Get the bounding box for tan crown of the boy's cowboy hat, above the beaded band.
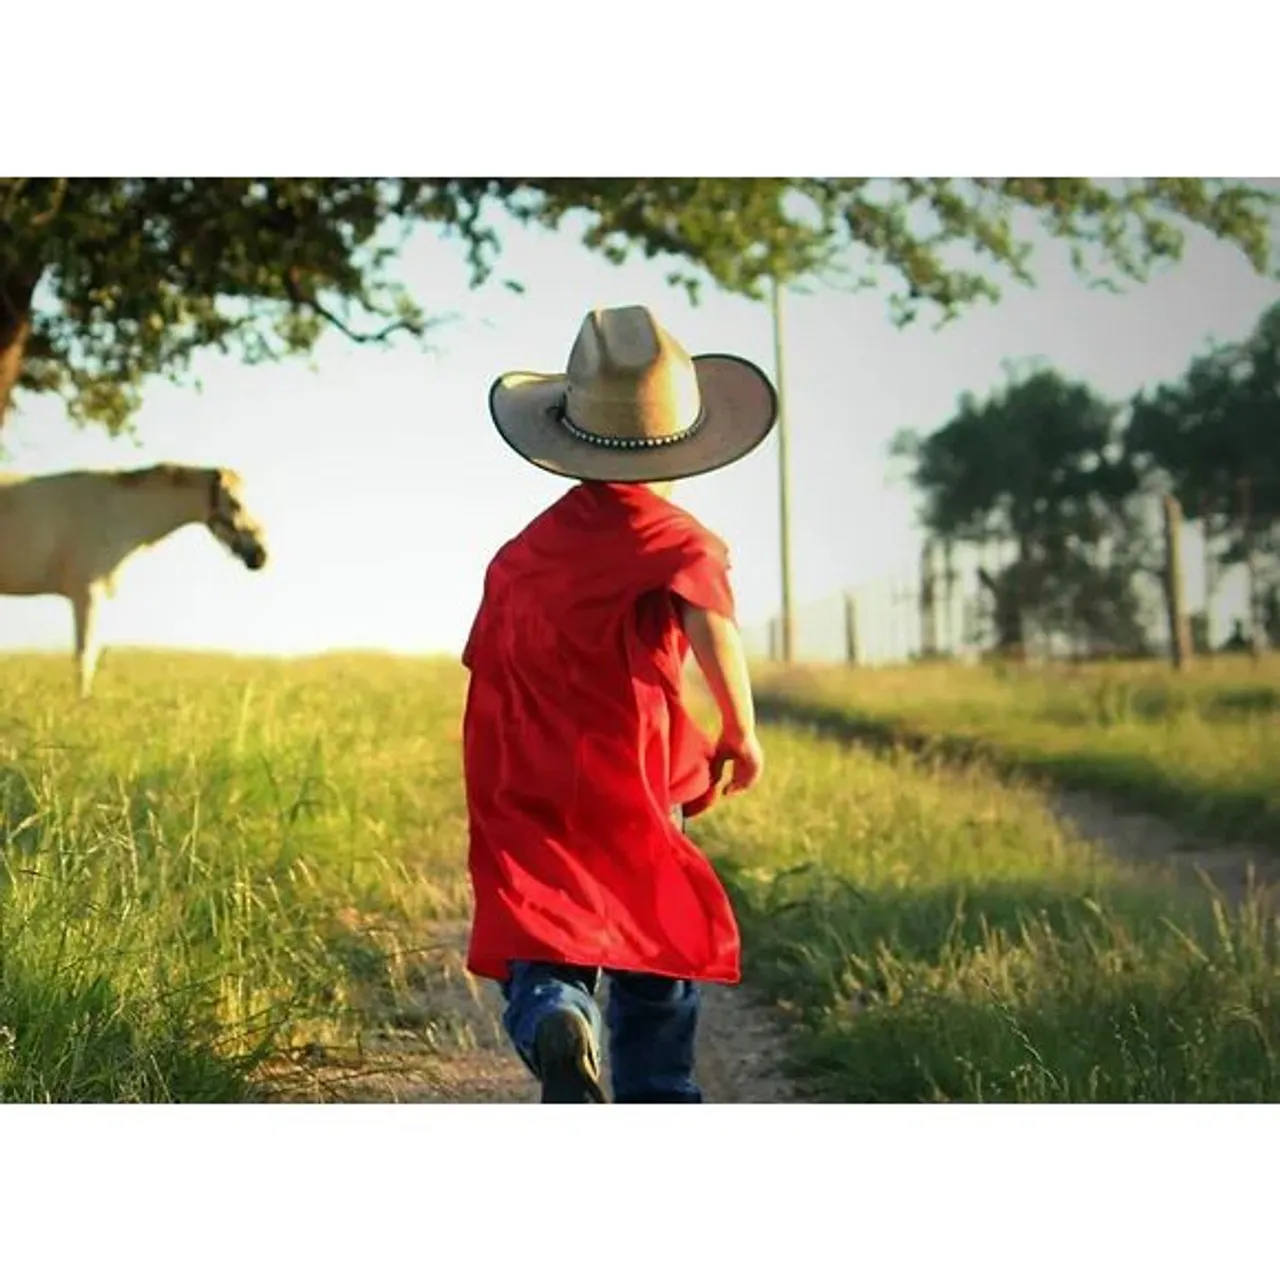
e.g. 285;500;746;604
564;306;701;442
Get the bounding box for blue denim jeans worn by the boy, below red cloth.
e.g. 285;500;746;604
502;809;703;1102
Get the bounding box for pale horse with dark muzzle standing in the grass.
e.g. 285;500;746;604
0;463;266;698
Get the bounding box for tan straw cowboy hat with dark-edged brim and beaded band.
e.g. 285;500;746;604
489;307;778;484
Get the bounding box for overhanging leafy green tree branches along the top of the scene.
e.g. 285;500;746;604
0;178;1276;431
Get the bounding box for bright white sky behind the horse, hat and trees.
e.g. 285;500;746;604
0;186;1280;653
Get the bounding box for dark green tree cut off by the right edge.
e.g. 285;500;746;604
1125;303;1280;643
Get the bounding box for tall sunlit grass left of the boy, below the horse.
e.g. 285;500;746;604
0;654;466;1101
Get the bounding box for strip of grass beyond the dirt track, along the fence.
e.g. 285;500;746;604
759;657;1280;846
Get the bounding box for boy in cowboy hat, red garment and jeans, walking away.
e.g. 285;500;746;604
462;307;777;1102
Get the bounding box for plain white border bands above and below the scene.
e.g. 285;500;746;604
0;0;1280;1280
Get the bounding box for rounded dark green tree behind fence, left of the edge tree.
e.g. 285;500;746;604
892;369;1158;652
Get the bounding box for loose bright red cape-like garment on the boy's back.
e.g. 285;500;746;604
462;484;739;982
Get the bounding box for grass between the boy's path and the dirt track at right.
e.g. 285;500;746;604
700;728;1280;1102
